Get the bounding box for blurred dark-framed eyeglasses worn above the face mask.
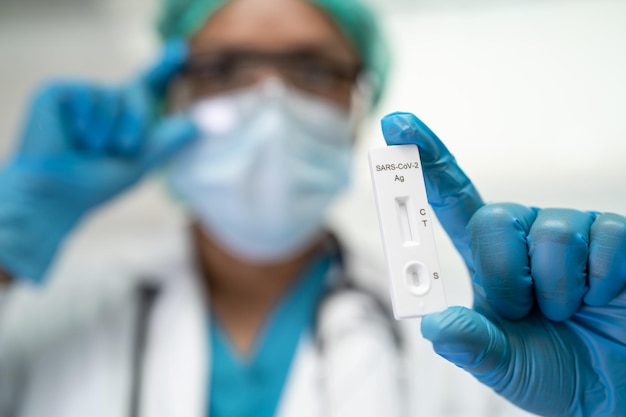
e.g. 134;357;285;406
176;50;361;103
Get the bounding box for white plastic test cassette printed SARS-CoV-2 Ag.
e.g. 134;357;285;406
369;145;447;319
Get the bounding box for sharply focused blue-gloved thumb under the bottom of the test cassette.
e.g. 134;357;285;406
421;307;508;376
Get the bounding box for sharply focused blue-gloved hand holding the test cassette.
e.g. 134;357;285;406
382;113;626;417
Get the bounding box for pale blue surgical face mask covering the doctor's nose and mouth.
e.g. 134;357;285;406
167;79;353;263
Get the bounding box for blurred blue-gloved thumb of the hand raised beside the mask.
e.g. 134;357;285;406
142;115;198;171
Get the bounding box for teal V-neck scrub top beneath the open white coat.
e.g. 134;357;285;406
208;250;332;417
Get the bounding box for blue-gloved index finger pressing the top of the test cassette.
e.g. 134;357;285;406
381;113;484;269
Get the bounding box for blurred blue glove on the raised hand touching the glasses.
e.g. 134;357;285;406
0;41;196;283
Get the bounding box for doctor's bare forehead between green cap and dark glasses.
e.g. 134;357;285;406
191;0;357;60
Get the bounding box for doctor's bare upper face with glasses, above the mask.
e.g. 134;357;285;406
180;0;360;109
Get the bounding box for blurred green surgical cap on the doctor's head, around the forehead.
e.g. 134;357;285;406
158;0;389;104
